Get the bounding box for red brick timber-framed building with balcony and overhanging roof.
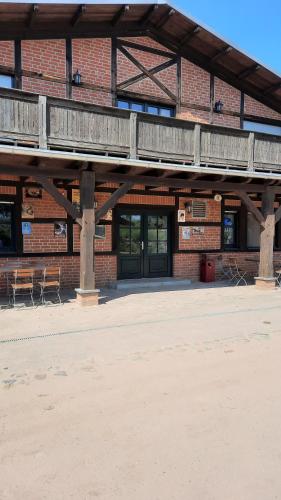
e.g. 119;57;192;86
0;4;281;302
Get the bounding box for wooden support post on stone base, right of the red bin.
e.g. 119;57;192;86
256;188;275;288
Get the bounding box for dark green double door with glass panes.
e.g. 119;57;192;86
117;211;171;279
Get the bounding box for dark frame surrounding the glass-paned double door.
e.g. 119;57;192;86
112;204;175;280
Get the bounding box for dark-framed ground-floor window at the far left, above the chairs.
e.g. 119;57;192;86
0;200;16;254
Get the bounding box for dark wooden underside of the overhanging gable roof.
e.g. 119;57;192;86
0;3;281;113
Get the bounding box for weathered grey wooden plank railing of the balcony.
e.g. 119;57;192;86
0;89;281;174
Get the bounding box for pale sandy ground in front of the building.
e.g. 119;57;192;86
0;286;281;500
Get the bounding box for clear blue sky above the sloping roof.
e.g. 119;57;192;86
175;0;281;74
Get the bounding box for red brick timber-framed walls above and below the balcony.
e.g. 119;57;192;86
0;2;281;291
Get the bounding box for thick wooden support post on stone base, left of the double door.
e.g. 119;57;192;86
76;170;99;305
